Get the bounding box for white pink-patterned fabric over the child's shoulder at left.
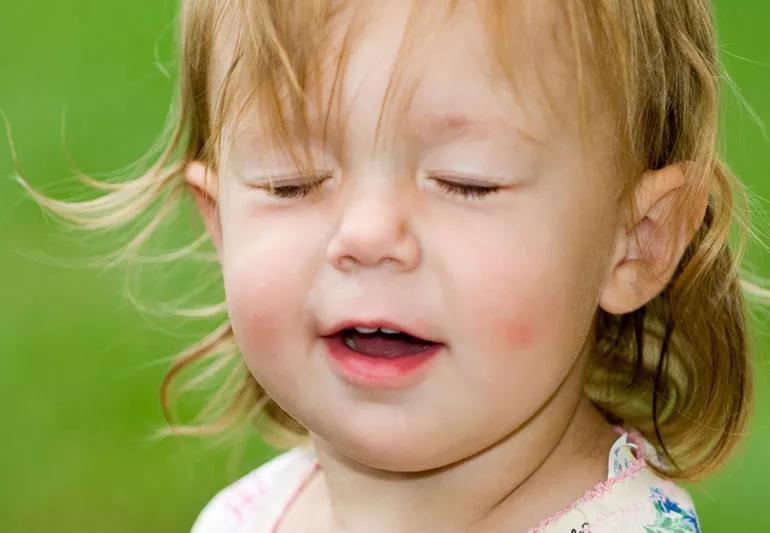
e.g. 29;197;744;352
191;445;315;533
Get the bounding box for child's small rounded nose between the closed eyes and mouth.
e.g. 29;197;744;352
327;182;420;272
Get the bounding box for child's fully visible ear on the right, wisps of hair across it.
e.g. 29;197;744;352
599;163;708;314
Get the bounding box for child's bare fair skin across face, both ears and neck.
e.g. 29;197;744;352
187;2;705;533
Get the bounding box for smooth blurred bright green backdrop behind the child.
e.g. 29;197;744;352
0;0;770;532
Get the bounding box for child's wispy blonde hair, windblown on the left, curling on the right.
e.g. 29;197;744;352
19;0;770;479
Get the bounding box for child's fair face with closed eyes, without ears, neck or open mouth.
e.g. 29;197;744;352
190;2;617;470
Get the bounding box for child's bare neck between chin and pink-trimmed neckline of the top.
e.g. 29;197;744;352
308;372;617;533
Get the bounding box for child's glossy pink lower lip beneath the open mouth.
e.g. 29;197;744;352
322;335;444;389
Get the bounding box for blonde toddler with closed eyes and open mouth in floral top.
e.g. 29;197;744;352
18;0;760;533
